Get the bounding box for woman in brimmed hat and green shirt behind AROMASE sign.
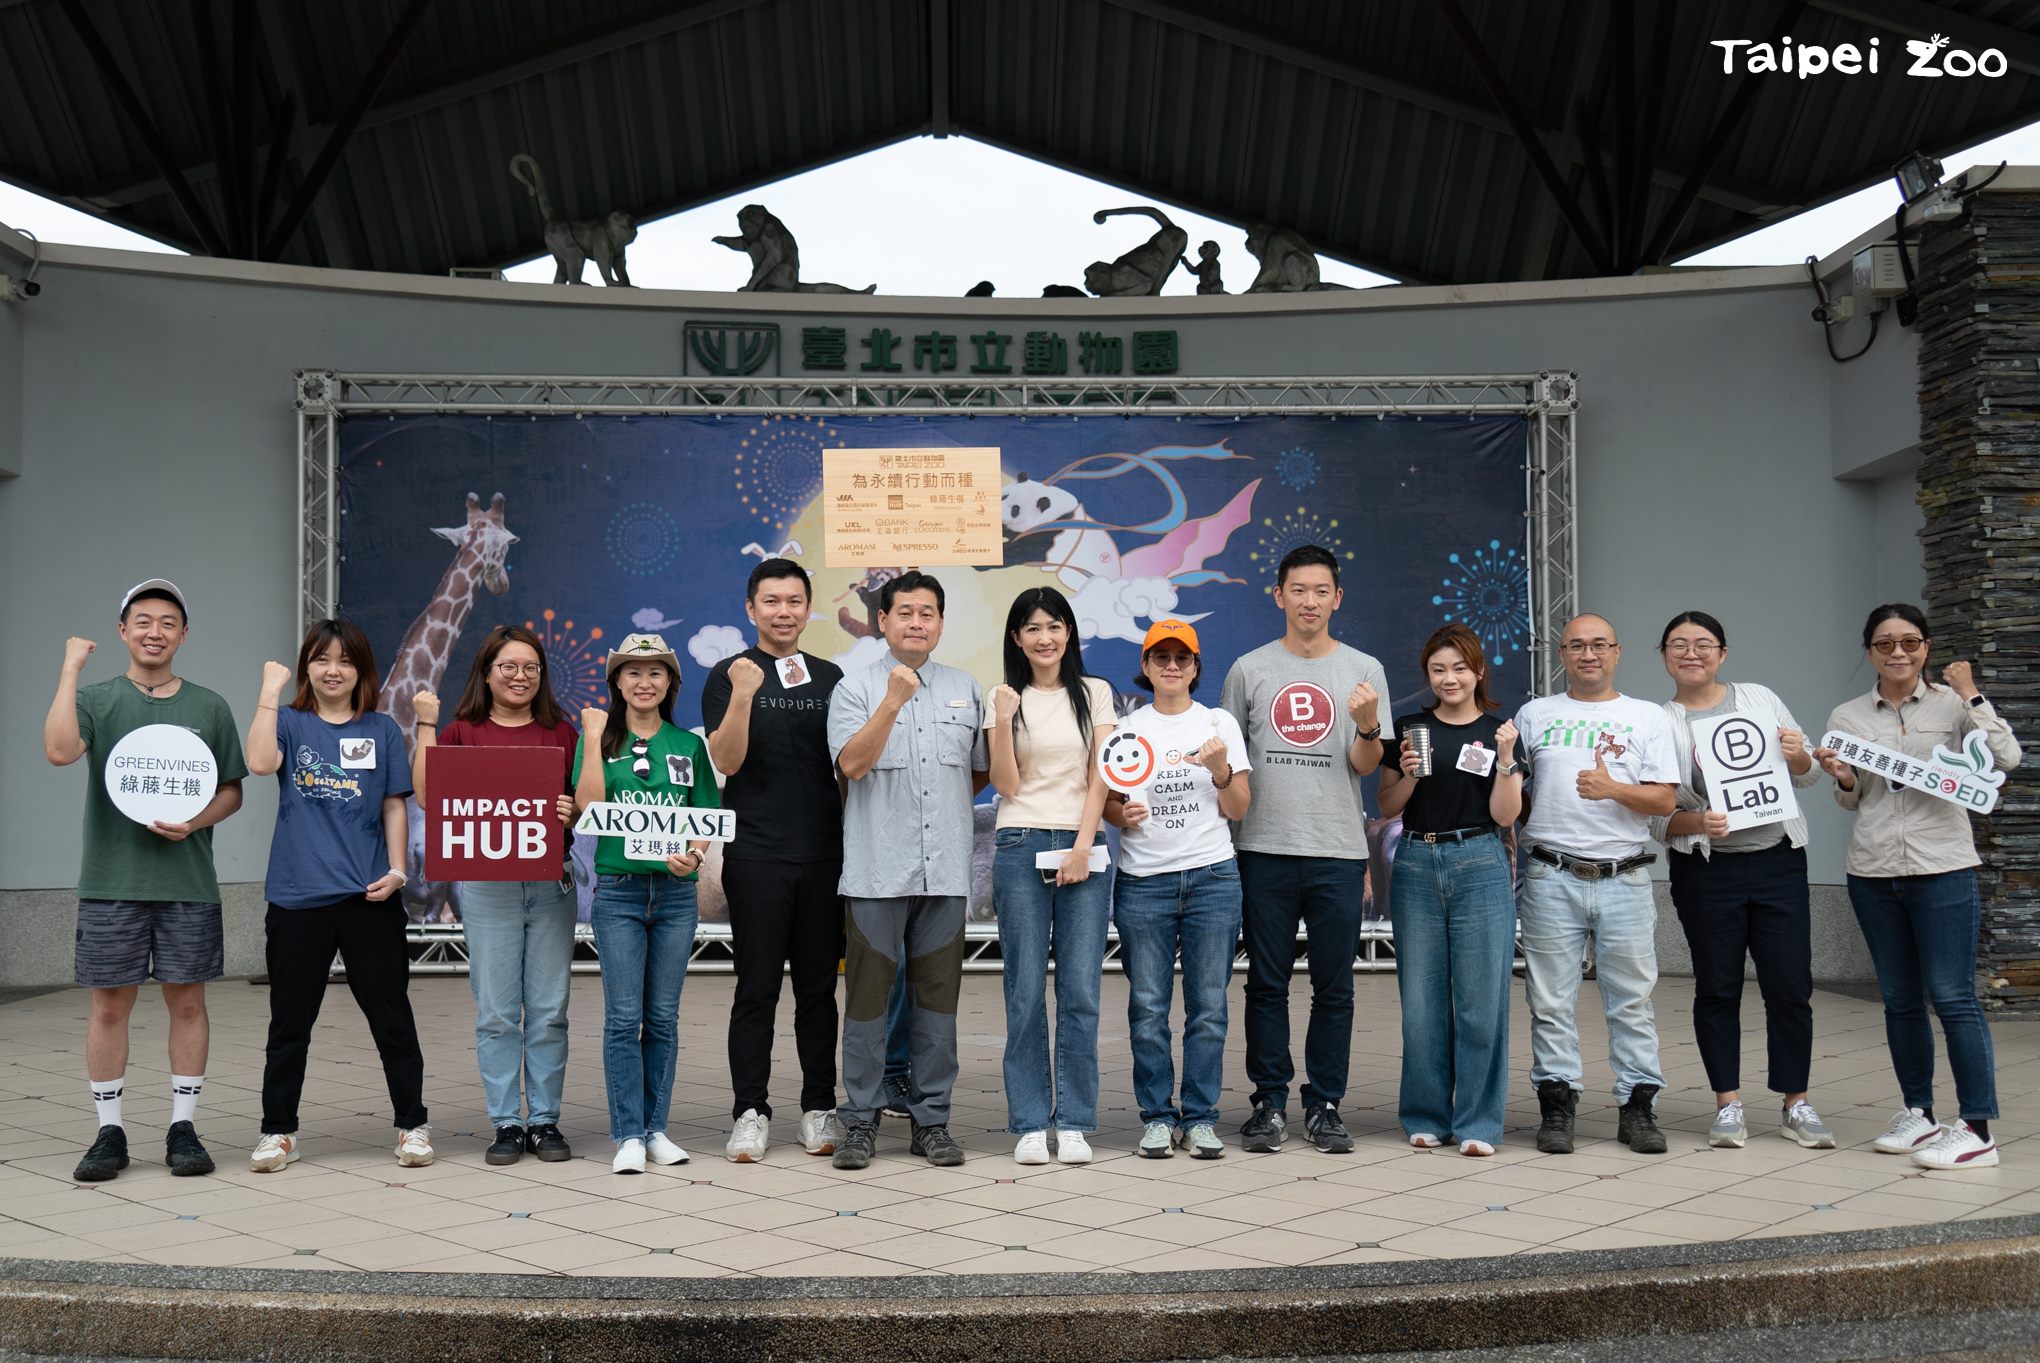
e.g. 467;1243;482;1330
573;635;722;1173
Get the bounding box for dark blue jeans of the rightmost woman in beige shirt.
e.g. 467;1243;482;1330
1848;869;1997;1122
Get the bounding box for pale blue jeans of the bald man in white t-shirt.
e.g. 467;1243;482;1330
1520;857;1665;1102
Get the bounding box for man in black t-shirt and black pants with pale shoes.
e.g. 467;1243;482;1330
702;559;843;1163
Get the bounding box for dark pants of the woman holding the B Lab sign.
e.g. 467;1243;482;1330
1671;841;1814;1094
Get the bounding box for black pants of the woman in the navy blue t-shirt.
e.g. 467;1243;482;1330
261;896;426;1137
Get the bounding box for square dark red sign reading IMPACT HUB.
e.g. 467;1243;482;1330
424;747;567;879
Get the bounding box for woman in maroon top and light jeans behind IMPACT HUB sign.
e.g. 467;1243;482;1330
410;624;579;1165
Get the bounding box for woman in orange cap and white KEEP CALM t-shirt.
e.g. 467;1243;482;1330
1102;620;1248;1159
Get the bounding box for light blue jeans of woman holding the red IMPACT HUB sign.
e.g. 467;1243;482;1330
461;879;575;1126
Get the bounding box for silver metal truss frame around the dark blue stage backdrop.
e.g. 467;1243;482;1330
294;369;1579;973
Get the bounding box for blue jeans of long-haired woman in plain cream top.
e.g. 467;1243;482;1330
991;828;1110;1137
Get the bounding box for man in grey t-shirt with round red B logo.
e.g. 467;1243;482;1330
1220;545;1387;1153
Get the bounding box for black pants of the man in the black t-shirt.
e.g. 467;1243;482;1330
722;861;843;1118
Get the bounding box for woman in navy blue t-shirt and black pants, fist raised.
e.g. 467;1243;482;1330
247;620;432;1173
